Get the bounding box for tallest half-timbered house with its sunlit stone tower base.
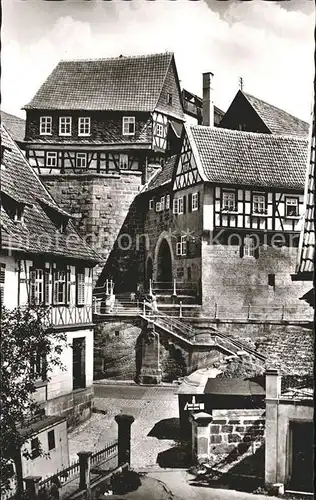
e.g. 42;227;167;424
25;52;184;284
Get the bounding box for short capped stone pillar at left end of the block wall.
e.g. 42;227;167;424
190;412;213;463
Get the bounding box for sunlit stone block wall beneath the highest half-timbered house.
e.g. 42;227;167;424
41;172;142;283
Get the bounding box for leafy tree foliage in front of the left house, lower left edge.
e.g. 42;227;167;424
0;307;66;491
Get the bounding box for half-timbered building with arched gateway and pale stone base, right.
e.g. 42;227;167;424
139;121;308;313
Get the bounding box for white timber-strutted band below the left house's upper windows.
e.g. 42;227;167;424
46;305;92;326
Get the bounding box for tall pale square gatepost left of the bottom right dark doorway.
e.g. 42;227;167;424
265;369;281;485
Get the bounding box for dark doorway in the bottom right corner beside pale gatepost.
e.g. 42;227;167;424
290;422;314;492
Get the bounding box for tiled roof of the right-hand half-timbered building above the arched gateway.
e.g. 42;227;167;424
189;125;308;190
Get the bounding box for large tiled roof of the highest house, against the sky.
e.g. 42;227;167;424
25;52;185;119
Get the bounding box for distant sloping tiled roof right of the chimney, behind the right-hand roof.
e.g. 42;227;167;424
242;92;308;136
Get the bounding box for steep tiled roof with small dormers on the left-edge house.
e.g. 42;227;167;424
0;124;101;262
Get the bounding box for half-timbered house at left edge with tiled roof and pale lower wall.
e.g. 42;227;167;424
0;125;99;438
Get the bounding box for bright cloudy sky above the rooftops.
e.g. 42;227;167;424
1;0;315;121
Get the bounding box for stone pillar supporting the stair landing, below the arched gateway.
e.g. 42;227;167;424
139;321;162;384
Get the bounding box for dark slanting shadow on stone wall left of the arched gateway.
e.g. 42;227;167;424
96;200;145;293
